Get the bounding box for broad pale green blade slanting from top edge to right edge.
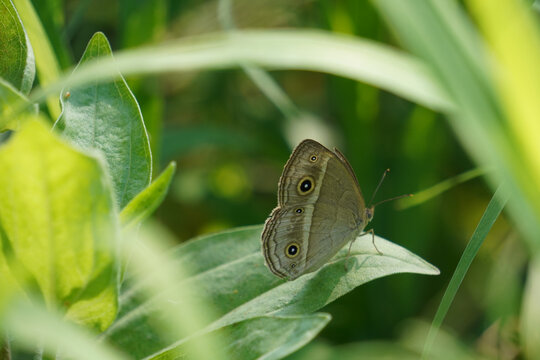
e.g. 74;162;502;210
373;0;540;260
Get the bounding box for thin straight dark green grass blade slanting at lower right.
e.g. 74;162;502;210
422;186;508;359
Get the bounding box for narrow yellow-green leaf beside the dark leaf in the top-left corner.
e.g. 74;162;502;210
13;0;60;118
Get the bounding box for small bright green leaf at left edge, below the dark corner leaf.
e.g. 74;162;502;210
0;78;29;132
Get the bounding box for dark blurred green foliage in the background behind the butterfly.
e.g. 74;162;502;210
2;0;538;359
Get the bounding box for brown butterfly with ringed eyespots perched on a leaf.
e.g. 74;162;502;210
262;140;373;280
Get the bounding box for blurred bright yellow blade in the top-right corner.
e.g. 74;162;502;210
466;0;540;250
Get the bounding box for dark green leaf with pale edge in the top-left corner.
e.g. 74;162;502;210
0;0;36;94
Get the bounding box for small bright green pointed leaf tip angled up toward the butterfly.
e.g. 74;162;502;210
120;161;176;228
